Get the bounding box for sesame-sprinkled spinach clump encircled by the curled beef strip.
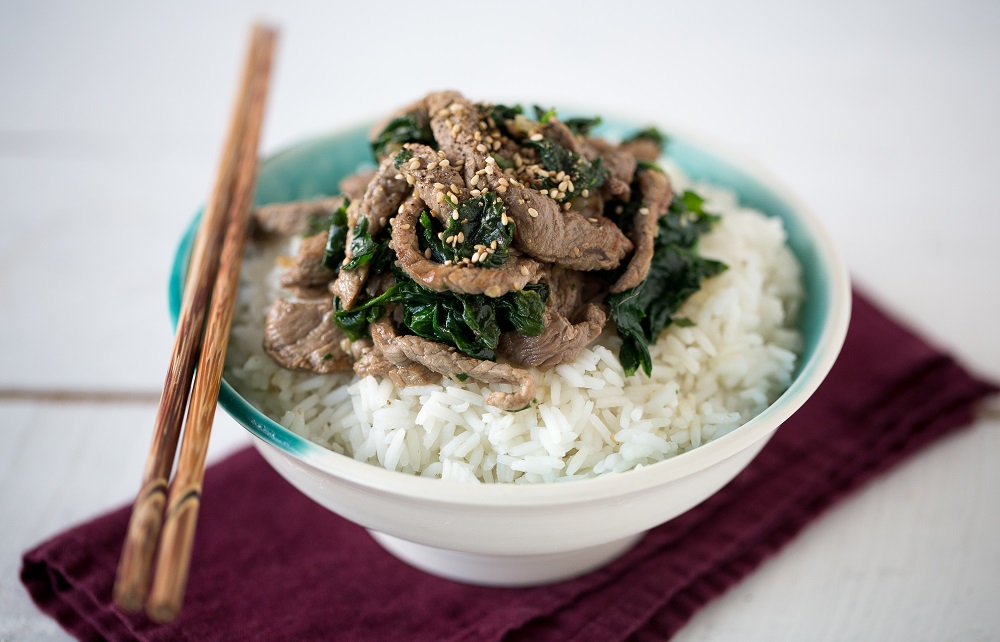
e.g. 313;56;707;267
418;192;514;268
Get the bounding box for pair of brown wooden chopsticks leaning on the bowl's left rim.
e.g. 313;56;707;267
114;25;277;622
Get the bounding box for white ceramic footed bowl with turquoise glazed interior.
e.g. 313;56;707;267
170;119;850;586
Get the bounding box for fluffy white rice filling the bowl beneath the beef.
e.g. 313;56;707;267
226;168;803;483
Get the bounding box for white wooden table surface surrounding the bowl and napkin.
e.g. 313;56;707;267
0;0;1000;641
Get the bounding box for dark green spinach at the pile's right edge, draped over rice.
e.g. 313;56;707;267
605;191;727;376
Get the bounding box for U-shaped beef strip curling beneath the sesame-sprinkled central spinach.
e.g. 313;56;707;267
392;194;541;297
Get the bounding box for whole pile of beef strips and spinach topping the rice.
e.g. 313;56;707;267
257;91;725;410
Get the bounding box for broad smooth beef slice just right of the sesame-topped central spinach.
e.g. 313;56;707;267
491;177;632;270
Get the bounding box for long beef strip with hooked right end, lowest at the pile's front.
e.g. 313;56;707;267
371;317;535;410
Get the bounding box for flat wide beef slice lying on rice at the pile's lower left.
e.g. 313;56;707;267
264;299;354;374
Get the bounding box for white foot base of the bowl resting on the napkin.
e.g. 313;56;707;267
368;531;645;587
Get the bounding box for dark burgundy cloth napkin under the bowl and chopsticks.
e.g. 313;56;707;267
21;295;997;642
